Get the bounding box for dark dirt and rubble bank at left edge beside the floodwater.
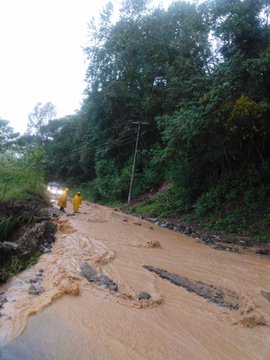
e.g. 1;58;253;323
0;200;56;282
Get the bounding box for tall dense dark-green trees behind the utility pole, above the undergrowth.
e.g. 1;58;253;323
39;0;270;207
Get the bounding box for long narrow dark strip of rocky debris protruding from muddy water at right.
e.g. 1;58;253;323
143;265;239;310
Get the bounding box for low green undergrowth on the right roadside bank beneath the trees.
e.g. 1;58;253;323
133;178;270;242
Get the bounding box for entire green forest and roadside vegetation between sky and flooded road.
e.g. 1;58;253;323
0;0;270;242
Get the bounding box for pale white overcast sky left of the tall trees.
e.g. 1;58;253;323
0;0;188;133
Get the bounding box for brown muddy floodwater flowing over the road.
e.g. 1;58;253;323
0;203;270;360
